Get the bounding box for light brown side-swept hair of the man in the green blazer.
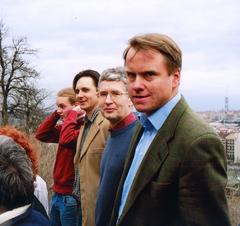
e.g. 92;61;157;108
123;33;182;73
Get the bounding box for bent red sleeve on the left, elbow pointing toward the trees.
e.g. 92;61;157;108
35;111;62;143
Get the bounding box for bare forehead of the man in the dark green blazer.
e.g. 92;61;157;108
125;48;166;71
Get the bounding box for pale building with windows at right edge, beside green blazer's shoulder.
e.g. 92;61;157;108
222;132;240;163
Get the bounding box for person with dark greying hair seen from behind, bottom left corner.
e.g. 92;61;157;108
0;135;50;226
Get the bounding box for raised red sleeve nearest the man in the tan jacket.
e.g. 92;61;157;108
59;110;82;145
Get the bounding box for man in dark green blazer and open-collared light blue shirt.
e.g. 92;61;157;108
111;34;230;226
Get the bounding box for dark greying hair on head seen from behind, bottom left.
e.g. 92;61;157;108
0;135;34;210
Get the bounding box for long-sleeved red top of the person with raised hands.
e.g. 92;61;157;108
36;111;83;195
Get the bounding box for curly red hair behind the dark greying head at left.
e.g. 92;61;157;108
0;125;38;176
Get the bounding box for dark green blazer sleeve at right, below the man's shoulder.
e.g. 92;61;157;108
178;134;231;226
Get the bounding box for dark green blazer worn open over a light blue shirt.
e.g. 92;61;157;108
111;98;230;226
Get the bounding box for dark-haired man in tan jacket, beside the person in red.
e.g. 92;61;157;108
73;69;109;226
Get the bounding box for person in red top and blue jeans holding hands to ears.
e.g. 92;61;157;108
36;88;84;226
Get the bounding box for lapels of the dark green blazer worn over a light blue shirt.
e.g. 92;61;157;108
117;97;187;223
